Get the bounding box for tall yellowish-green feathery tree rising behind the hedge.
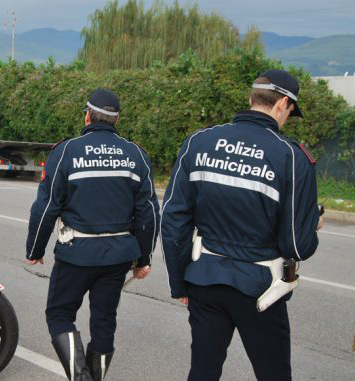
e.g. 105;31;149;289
79;0;243;72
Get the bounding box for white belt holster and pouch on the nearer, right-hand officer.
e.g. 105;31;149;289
192;234;298;312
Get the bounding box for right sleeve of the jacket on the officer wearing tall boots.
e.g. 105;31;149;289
134;149;160;267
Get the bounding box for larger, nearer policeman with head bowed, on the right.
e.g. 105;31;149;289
161;70;322;381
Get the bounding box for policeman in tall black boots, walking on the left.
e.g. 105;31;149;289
26;89;159;381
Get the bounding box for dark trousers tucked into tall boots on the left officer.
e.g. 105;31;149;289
46;260;132;353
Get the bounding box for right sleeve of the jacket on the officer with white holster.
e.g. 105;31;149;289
278;147;319;261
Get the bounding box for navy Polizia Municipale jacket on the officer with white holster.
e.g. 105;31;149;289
161;111;319;298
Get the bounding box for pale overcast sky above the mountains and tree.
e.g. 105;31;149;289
0;0;355;37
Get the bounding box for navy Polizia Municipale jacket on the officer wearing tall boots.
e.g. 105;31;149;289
26;123;159;267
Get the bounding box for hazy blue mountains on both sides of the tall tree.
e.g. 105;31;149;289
0;28;355;76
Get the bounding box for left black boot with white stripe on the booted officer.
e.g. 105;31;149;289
52;331;93;381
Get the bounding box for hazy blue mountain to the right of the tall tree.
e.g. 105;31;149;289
269;35;355;76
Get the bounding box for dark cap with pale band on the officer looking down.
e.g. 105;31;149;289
252;69;303;118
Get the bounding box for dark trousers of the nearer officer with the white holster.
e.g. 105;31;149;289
188;284;291;381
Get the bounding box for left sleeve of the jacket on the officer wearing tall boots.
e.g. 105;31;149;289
26;142;67;259
